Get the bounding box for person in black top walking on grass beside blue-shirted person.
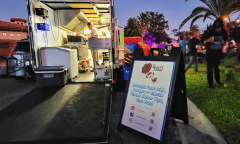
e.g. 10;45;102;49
185;31;200;73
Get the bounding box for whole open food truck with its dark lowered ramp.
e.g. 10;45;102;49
0;0;124;143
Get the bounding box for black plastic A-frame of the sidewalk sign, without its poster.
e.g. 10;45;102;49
118;48;188;144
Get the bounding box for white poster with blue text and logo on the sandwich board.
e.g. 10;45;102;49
121;60;175;141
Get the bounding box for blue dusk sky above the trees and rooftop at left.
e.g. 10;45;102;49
0;0;238;37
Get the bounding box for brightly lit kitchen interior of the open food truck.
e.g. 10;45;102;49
28;0;124;82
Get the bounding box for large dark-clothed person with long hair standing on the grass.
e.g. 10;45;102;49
204;18;228;88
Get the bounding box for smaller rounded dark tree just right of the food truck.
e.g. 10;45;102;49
124;18;142;37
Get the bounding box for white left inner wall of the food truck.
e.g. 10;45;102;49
27;0;76;67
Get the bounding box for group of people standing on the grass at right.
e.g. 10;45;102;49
178;19;238;88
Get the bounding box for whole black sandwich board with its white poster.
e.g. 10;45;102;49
118;48;188;143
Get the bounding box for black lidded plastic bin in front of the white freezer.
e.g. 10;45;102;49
34;66;68;87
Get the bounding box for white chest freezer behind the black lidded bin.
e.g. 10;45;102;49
40;47;78;79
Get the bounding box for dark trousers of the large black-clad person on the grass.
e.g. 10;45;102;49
207;56;221;85
